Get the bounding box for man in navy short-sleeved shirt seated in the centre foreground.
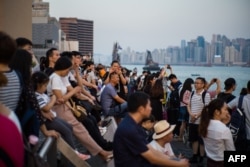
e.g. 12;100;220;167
113;92;189;167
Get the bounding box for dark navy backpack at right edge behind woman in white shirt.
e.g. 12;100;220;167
228;96;247;151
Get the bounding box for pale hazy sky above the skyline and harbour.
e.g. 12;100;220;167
47;0;250;55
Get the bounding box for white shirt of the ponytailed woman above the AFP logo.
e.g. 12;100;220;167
202;120;235;161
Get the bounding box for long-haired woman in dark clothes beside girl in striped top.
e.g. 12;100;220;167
9;49;59;138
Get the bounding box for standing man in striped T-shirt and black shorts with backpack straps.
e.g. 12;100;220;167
187;77;211;165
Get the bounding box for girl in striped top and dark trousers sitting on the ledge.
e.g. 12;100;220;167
31;71;90;160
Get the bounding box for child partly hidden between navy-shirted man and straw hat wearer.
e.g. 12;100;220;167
141;115;155;143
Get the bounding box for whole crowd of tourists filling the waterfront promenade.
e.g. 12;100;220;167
0;31;250;167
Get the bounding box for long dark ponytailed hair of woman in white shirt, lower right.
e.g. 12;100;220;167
199;99;225;137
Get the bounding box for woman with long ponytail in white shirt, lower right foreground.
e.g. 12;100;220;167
199;99;235;167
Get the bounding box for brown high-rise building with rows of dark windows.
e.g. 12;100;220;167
59;18;94;56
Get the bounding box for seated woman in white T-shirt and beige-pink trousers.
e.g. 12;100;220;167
47;57;112;160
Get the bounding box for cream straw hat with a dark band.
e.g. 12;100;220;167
153;120;175;139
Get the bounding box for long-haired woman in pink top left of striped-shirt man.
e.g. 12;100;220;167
178;78;194;141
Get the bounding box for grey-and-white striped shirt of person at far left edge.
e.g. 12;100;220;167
0;70;21;111
